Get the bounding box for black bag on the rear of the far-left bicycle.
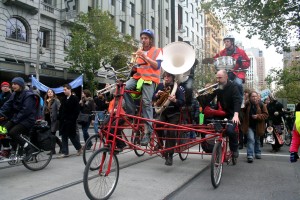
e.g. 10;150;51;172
30;120;56;151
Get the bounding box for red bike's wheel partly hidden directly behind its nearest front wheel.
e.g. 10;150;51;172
82;134;104;165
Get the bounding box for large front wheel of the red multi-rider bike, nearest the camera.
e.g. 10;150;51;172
83;148;119;200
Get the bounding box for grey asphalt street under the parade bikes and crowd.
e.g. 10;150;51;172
0;138;300;200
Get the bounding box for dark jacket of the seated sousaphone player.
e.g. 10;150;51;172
152;83;184;115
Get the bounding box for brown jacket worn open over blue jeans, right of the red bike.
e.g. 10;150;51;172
242;101;269;136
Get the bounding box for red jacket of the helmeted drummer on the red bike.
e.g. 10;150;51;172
214;46;250;82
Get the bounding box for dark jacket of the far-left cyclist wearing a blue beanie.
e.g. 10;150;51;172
0;90;37;129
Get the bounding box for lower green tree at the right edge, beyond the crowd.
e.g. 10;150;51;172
266;62;300;103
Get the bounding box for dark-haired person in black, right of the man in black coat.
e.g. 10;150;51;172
79;89;95;149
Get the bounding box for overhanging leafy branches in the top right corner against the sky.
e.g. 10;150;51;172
201;0;300;52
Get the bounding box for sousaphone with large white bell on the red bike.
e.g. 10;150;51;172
154;42;196;114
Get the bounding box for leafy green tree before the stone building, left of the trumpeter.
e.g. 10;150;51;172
65;9;134;91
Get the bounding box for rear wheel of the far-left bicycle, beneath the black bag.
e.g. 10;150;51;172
22;149;52;171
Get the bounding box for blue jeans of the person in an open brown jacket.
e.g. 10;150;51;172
247;128;261;158
